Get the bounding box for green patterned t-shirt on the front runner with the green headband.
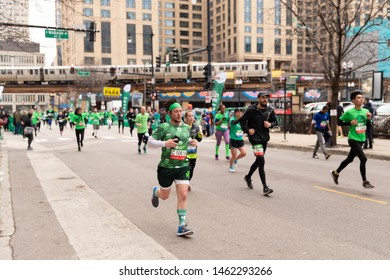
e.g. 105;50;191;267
152;123;190;168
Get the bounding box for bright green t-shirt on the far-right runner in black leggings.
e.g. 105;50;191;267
340;108;369;142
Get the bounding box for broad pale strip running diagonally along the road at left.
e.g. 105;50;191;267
27;152;176;260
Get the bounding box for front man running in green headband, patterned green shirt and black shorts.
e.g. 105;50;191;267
149;99;198;236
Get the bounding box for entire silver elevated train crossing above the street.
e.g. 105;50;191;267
0;61;268;85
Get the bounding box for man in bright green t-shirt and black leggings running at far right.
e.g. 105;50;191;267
331;90;374;189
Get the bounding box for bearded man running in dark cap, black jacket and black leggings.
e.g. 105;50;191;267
239;92;278;195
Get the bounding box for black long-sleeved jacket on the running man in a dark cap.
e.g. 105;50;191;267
239;105;278;144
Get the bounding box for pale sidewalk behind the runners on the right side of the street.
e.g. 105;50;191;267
269;132;390;160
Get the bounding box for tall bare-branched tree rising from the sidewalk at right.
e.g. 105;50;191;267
281;0;390;145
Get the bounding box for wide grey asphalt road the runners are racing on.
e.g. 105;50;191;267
0;128;390;260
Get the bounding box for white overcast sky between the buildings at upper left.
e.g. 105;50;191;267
29;0;56;66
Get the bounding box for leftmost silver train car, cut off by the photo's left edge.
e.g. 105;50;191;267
0;66;42;85
